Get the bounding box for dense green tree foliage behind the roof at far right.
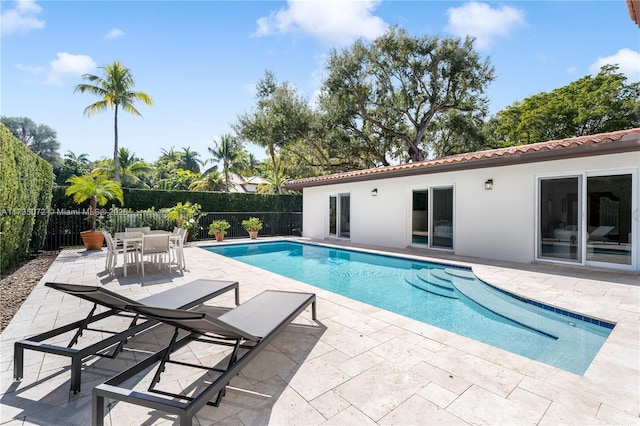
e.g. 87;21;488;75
494;65;640;146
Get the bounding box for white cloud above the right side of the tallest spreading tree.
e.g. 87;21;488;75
447;2;525;50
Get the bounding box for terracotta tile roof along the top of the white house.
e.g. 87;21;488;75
286;128;640;189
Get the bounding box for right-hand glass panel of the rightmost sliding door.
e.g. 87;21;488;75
587;174;633;265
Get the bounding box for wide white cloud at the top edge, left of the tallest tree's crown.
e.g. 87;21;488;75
253;0;388;45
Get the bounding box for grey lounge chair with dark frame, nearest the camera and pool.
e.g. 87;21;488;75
91;290;316;426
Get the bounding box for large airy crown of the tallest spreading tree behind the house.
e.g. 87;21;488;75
320;27;494;164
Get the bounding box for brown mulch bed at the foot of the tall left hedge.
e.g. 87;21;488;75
0;252;58;332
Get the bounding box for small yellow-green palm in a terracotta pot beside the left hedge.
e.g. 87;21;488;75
65;175;124;250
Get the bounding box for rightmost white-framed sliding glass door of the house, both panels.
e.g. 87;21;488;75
537;173;638;267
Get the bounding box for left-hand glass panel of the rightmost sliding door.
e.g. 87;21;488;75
538;176;582;262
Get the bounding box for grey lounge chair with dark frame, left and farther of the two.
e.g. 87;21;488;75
13;280;240;394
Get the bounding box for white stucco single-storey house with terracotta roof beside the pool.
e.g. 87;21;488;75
287;128;640;271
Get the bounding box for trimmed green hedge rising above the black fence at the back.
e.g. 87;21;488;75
52;187;302;212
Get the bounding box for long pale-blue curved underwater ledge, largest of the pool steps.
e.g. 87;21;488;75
452;276;557;338
